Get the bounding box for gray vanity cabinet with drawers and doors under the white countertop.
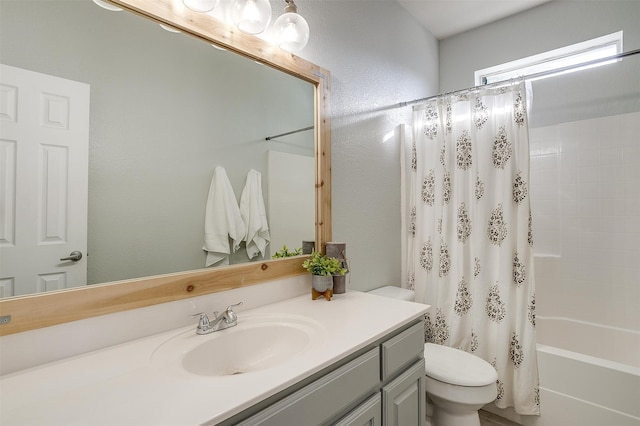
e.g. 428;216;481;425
222;321;426;426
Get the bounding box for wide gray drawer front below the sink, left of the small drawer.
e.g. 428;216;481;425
240;348;380;426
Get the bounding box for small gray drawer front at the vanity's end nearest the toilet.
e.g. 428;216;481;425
381;322;424;380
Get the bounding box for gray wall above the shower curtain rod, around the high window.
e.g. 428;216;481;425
440;0;640;92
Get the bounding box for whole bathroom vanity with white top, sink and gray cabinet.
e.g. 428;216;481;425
0;292;428;426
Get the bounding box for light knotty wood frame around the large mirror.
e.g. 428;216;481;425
0;0;331;335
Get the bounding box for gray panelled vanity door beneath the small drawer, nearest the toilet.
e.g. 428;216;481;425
382;359;426;426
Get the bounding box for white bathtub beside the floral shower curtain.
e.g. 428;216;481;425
486;316;640;426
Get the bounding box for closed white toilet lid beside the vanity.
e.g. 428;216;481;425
424;343;498;386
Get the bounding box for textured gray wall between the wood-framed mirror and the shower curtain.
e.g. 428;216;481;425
296;0;438;290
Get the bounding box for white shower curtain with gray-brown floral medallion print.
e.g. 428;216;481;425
406;81;540;415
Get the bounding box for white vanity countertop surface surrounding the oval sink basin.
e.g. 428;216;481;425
0;292;428;426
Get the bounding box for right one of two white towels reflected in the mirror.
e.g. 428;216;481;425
240;169;271;259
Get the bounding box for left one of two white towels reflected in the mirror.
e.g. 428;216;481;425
202;166;247;267
